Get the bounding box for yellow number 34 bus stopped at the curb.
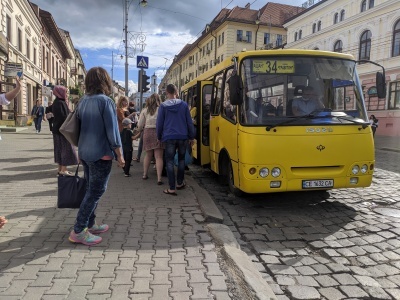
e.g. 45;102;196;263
181;49;385;194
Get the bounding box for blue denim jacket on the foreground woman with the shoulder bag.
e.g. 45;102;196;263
77;94;121;162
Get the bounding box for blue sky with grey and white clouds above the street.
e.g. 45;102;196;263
31;0;305;95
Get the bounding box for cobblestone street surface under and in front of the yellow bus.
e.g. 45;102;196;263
191;144;400;300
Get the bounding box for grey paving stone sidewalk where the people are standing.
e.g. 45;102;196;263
0;126;234;300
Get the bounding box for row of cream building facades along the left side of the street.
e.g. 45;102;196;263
0;0;86;125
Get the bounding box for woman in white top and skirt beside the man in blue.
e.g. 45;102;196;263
138;94;164;185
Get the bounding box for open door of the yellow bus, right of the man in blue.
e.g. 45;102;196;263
192;81;212;166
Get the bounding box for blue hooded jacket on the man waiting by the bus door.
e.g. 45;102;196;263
156;99;194;142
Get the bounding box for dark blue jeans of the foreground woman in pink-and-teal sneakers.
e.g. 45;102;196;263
74;159;112;233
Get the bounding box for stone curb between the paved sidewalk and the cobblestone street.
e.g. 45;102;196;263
186;176;277;300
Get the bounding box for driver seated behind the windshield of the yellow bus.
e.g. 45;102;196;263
292;86;325;116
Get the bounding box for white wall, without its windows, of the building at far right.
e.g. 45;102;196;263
284;0;400;135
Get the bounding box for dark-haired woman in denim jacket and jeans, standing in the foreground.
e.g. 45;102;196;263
69;67;124;246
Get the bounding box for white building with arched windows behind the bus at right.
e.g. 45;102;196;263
284;0;400;136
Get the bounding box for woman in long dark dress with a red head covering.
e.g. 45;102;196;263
52;85;78;176
